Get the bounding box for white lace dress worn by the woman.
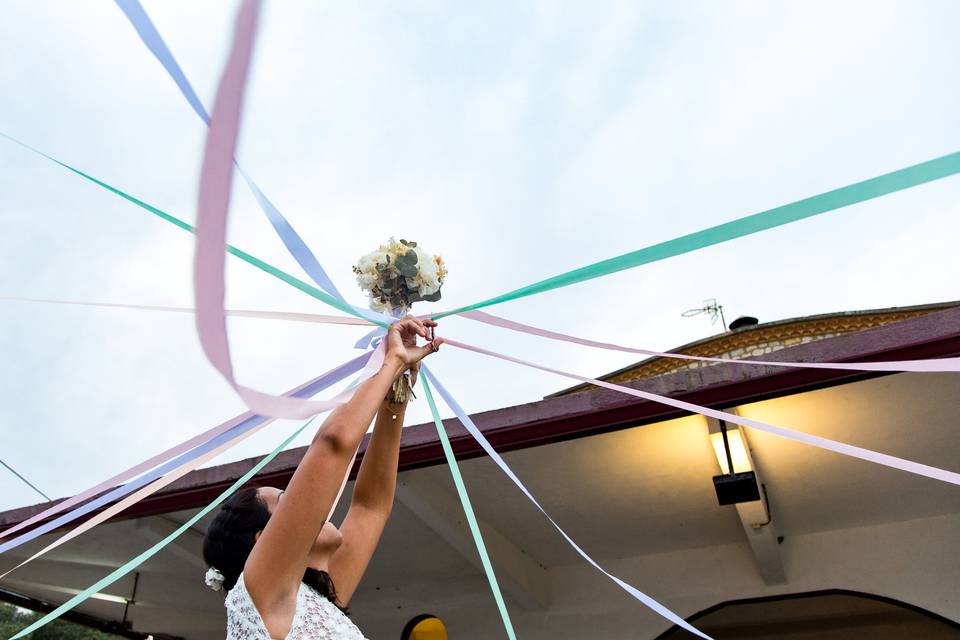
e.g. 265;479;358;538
225;574;366;640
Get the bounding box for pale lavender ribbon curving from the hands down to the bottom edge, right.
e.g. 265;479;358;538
421;370;712;640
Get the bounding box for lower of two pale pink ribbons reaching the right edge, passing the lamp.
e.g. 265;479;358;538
445;338;960;485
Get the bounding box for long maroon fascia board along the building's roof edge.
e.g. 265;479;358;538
0;308;960;527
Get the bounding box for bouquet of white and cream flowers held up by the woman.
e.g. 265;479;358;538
353;238;447;402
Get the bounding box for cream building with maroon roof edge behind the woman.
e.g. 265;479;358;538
0;308;960;640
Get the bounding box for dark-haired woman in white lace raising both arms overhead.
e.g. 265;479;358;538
203;316;443;640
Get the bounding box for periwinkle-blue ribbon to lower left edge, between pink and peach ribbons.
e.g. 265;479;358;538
0;351;382;553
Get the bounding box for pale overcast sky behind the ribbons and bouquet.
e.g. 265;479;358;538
0;0;960;509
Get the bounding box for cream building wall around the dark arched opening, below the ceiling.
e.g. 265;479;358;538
353;514;960;640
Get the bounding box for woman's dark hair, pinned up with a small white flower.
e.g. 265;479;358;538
203;487;347;613
